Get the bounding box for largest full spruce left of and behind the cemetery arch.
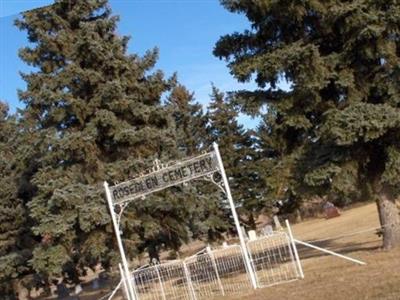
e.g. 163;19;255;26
16;0;187;282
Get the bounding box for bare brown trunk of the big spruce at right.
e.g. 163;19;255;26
377;186;400;249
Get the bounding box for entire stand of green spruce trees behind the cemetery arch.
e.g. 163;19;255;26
0;0;400;299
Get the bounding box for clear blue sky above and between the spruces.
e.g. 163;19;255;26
0;0;257;127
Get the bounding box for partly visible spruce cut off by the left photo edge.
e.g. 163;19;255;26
0;101;36;299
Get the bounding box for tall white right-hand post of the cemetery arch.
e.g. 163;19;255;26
213;143;257;289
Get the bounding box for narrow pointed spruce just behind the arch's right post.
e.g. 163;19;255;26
207;86;262;228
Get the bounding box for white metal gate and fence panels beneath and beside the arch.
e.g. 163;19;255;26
127;232;301;300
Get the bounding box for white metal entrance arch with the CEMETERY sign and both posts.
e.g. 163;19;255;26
104;143;256;300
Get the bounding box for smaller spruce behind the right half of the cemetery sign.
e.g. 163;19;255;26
167;84;229;242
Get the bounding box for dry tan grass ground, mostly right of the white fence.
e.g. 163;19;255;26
41;203;400;300
